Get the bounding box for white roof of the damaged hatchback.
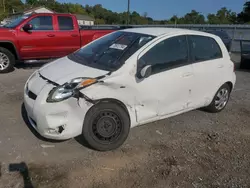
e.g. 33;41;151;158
123;27;214;36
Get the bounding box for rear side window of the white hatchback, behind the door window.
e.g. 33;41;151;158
188;35;222;62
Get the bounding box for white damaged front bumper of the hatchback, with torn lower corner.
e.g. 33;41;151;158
24;72;93;140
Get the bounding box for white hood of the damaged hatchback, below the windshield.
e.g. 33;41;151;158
39;57;108;85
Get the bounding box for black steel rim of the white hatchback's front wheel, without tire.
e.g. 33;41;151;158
92;111;122;142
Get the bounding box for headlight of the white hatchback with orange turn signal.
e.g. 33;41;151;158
47;78;97;102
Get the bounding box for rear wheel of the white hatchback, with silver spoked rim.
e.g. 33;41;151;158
205;84;231;113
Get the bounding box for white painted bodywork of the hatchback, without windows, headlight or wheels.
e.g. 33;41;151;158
24;28;236;139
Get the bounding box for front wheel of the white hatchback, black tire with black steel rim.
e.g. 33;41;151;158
82;102;130;151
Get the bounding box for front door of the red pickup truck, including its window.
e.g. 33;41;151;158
17;15;60;59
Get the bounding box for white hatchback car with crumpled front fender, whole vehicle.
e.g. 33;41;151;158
24;28;236;151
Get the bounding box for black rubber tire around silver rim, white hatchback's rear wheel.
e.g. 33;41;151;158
205;84;231;113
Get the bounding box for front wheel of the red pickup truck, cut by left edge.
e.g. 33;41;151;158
0;47;16;73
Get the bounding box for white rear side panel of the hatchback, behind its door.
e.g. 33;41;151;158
189;36;236;108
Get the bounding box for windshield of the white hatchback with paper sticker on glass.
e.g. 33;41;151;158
68;31;154;71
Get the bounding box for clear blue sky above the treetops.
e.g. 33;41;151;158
59;0;245;19
